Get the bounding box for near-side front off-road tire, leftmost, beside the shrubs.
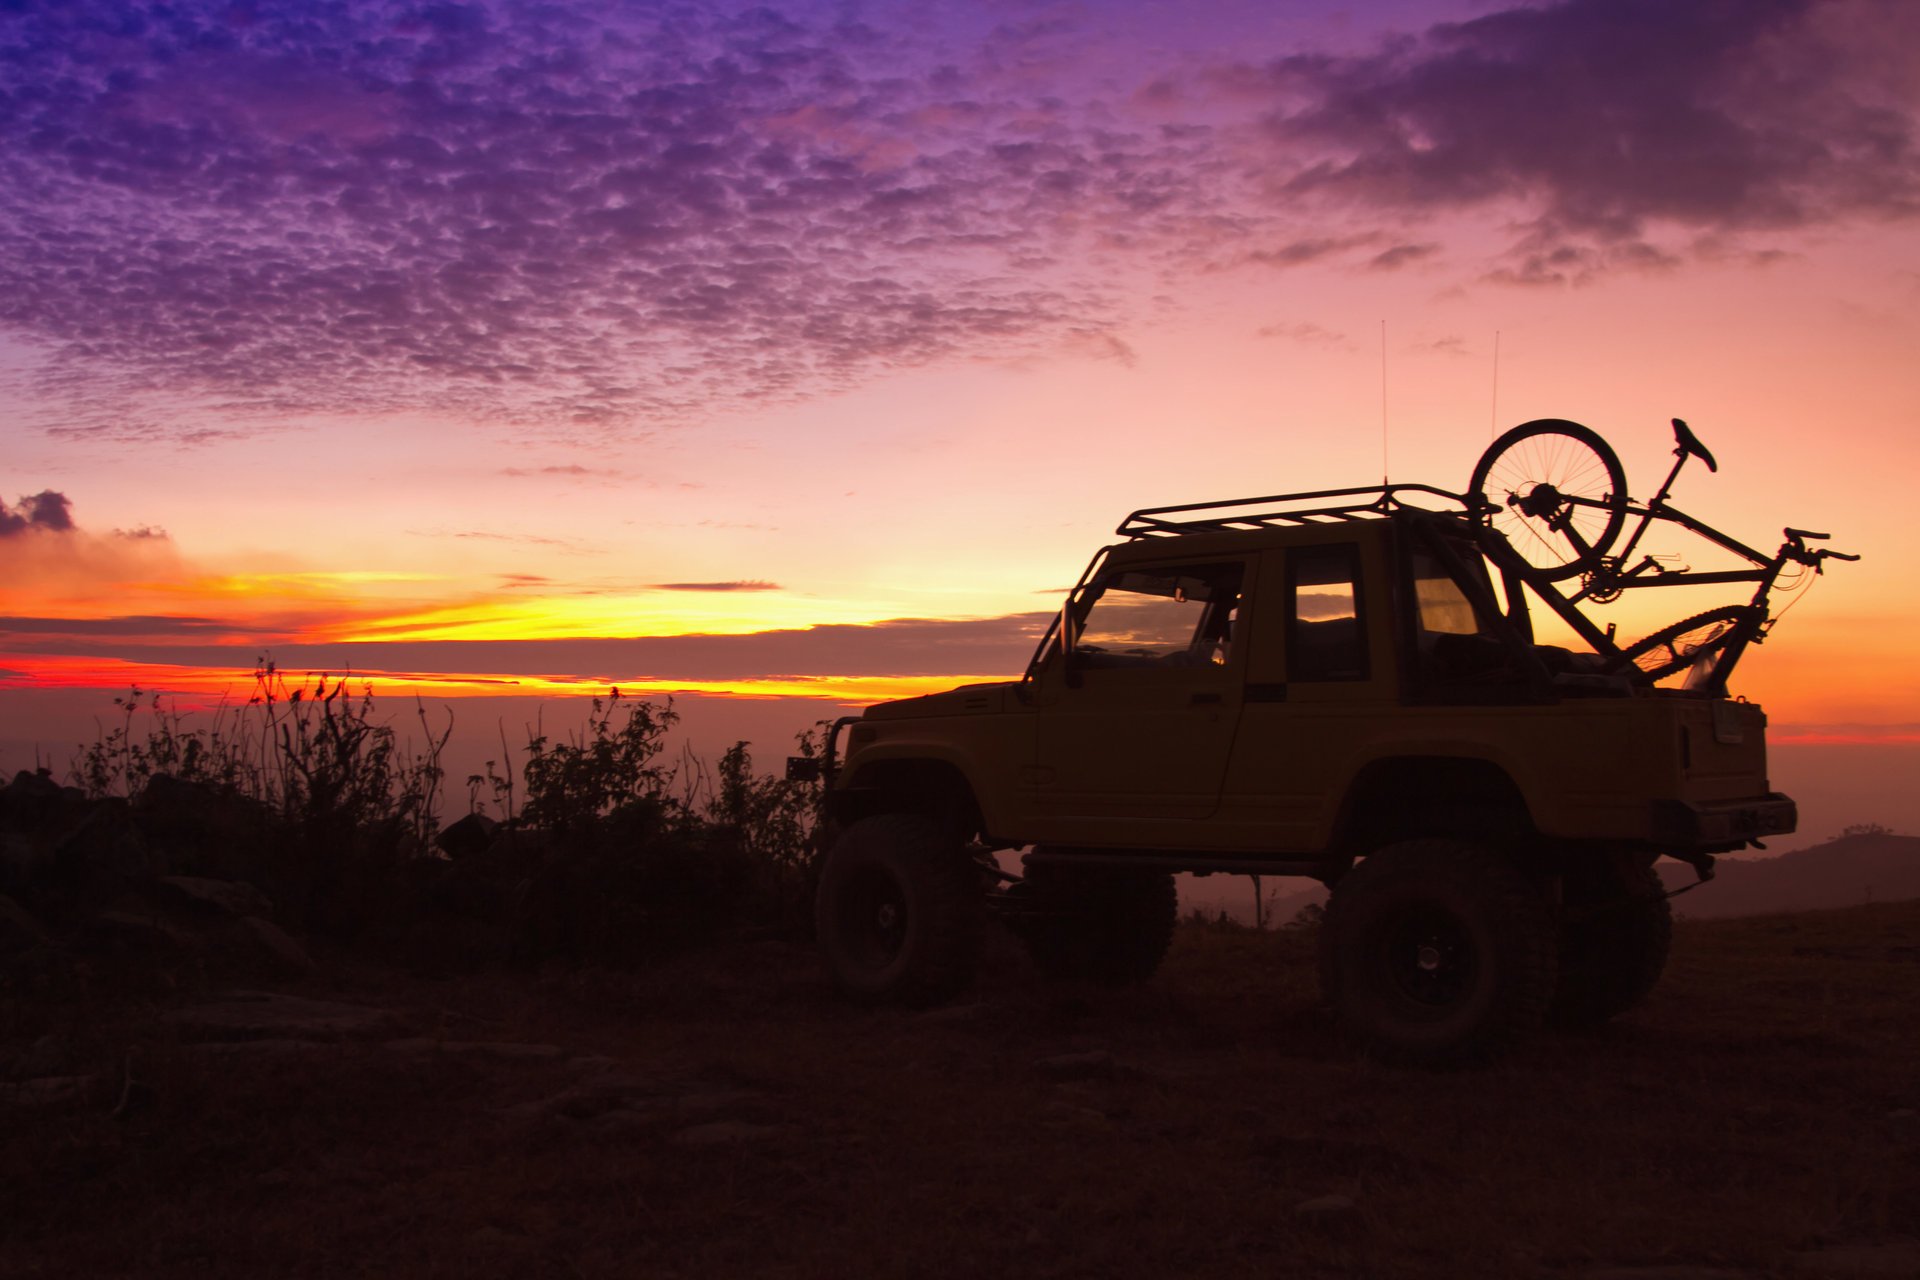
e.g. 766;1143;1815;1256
814;814;985;1006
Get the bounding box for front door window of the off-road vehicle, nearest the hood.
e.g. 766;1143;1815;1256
1073;564;1240;668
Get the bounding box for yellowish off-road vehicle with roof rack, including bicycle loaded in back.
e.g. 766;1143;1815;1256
795;418;1851;1061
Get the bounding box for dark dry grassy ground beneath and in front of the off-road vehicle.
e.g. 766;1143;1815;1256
0;904;1920;1280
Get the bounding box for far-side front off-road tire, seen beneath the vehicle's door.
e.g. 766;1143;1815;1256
1008;865;1181;986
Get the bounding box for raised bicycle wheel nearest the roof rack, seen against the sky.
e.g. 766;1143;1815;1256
1467;418;1626;581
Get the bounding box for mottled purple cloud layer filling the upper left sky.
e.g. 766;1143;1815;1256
0;0;1181;434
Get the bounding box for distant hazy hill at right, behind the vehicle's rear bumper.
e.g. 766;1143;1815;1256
1661;835;1920;919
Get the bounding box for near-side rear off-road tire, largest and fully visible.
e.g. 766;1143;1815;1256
1321;839;1559;1065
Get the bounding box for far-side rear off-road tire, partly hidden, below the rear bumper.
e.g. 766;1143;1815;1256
1551;856;1674;1027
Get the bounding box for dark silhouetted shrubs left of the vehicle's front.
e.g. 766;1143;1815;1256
58;675;822;960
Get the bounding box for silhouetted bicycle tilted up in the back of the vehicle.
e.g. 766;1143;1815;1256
1469;418;1860;695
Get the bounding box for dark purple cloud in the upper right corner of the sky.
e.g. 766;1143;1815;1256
1238;0;1920;284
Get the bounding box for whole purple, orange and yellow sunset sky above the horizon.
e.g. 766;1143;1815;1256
0;0;1920;836
